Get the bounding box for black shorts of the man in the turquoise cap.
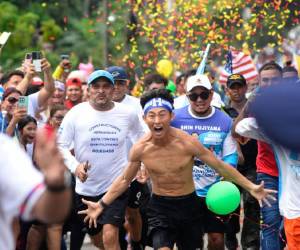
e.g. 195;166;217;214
75;191;128;236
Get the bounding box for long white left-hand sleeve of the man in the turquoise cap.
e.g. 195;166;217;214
57;111;79;173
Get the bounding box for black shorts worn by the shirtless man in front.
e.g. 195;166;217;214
147;193;203;250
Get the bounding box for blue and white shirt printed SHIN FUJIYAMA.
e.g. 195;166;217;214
171;105;238;197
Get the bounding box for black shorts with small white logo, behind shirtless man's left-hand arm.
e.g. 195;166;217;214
127;180;150;208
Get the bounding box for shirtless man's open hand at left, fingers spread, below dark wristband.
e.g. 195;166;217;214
78;199;103;228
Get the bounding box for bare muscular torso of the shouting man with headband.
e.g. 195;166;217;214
141;128;195;196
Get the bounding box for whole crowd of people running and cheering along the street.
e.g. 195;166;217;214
0;47;300;250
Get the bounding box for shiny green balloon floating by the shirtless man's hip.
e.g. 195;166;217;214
206;181;241;215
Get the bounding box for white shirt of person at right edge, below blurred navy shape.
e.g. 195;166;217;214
236;118;300;219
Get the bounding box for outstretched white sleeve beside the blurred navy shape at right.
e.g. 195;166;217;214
235;117;272;143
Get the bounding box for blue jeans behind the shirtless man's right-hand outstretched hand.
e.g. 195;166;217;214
257;173;284;250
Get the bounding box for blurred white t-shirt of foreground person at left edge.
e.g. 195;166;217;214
0;134;45;250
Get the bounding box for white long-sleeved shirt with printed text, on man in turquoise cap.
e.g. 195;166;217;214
58;102;144;196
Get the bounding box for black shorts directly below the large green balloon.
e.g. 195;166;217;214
198;197;229;233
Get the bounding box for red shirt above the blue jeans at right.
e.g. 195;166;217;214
256;141;278;177
